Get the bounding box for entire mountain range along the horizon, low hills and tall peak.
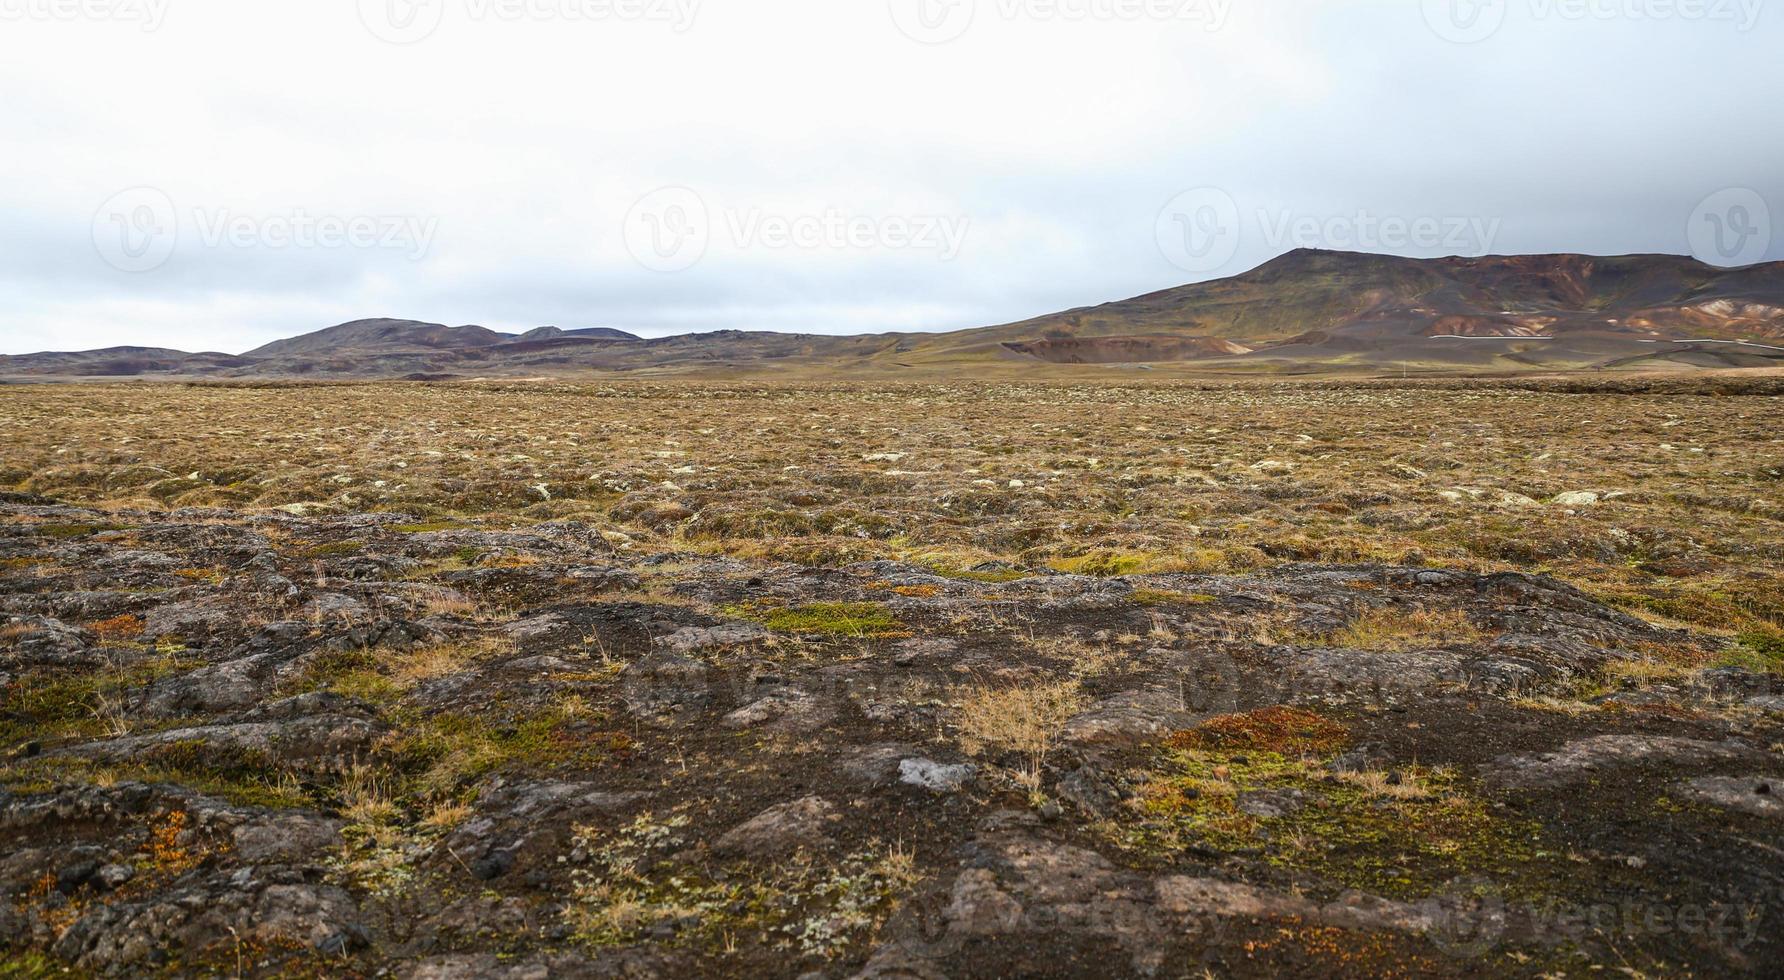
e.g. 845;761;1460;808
0;250;1784;378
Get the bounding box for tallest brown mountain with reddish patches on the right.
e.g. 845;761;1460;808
870;250;1784;373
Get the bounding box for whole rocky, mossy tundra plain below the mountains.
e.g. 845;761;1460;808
0;375;1784;978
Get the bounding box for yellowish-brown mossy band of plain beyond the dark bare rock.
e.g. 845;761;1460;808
5;380;1784;653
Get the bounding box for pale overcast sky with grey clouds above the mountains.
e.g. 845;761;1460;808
0;0;1784;353
